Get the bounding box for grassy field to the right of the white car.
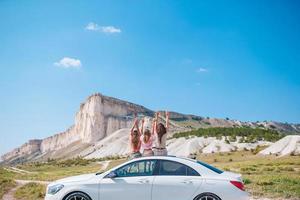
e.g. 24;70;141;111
198;152;300;199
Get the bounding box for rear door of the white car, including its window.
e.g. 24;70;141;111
152;160;202;200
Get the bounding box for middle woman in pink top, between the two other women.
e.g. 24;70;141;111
141;119;154;156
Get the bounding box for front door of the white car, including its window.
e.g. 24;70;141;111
99;160;156;200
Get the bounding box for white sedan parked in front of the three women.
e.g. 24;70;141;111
45;156;249;200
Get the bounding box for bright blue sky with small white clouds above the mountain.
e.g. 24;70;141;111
0;0;300;154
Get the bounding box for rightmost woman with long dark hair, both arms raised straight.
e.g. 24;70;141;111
153;111;169;156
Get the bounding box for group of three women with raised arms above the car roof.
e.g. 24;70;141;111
129;111;169;159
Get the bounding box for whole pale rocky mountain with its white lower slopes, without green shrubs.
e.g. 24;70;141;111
0;93;300;163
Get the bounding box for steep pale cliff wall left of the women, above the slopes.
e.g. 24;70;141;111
2;93;153;161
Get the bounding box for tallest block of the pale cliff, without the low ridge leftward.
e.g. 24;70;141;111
74;94;152;143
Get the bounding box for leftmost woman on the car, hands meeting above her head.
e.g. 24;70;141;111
129;118;142;159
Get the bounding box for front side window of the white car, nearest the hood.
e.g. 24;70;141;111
116;160;156;177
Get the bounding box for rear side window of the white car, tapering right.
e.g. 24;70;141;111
159;160;200;176
